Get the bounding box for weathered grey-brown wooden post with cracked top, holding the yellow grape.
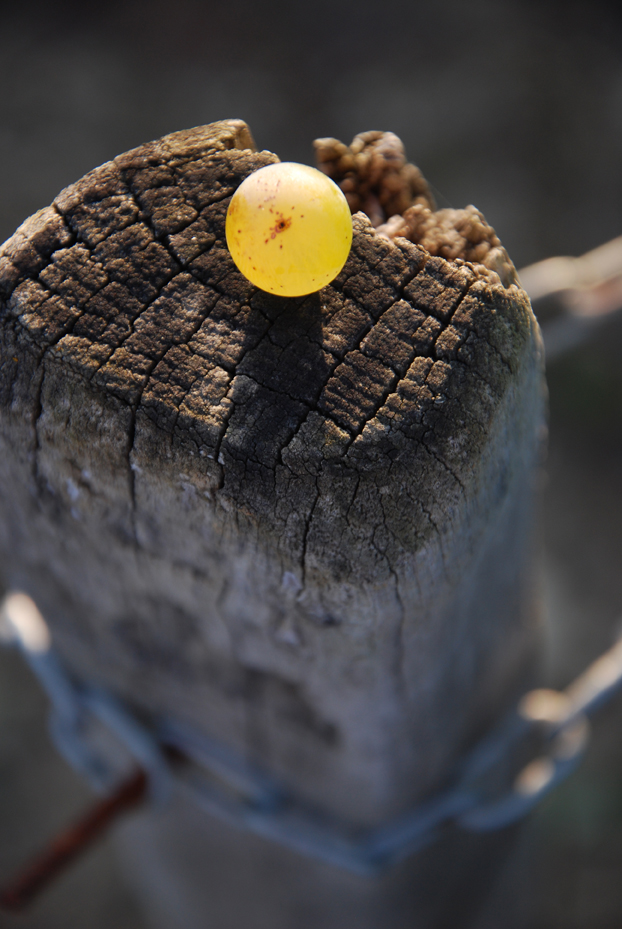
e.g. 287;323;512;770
0;120;543;929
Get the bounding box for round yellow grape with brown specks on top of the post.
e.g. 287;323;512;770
226;162;352;297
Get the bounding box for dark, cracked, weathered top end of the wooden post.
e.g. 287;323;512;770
0;120;538;581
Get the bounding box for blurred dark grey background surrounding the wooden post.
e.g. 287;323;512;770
0;0;622;929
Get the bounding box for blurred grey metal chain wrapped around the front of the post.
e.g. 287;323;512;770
0;593;622;874
